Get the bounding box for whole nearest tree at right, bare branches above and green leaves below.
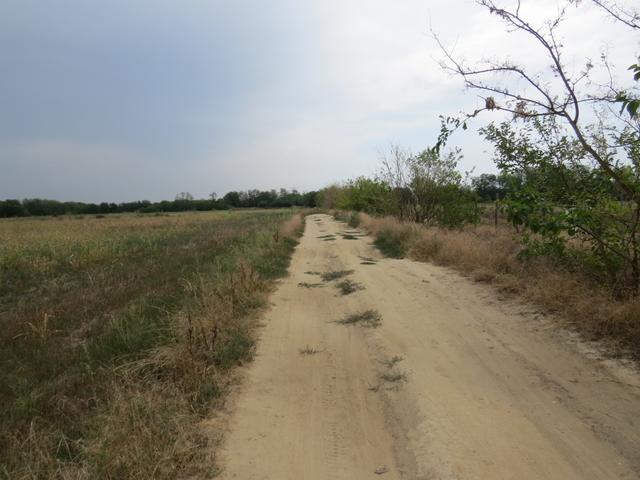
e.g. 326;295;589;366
438;0;640;294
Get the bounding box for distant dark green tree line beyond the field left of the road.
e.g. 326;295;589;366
0;189;316;218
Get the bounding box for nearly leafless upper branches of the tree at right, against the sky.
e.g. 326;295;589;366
436;0;640;201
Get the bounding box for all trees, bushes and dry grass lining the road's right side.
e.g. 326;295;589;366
318;0;640;356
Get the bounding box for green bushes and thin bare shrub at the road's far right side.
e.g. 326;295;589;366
316;145;522;228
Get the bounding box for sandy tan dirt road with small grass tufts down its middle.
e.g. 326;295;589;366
216;215;640;480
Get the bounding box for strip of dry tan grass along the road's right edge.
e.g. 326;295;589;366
360;214;640;356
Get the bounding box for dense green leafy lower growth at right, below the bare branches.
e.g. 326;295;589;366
482;117;640;295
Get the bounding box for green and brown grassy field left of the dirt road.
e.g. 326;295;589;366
0;211;302;479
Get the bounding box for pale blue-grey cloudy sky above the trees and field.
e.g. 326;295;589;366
0;0;639;202
